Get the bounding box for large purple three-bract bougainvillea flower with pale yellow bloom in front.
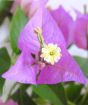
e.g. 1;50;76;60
3;7;86;84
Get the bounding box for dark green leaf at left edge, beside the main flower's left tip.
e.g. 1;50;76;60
0;48;11;94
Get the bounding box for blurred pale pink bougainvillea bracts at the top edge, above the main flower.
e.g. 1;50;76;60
11;0;48;18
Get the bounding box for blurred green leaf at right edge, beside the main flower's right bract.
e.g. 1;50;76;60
74;56;88;77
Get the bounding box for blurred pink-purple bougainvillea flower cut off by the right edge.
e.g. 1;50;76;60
70;14;88;49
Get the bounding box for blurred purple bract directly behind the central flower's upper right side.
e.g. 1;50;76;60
51;6;73;46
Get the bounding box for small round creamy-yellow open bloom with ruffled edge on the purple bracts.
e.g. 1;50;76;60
41;43;62;65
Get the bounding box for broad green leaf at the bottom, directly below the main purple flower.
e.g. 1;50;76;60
33;85;67;105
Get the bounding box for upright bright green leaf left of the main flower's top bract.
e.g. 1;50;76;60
10;8;27;54
